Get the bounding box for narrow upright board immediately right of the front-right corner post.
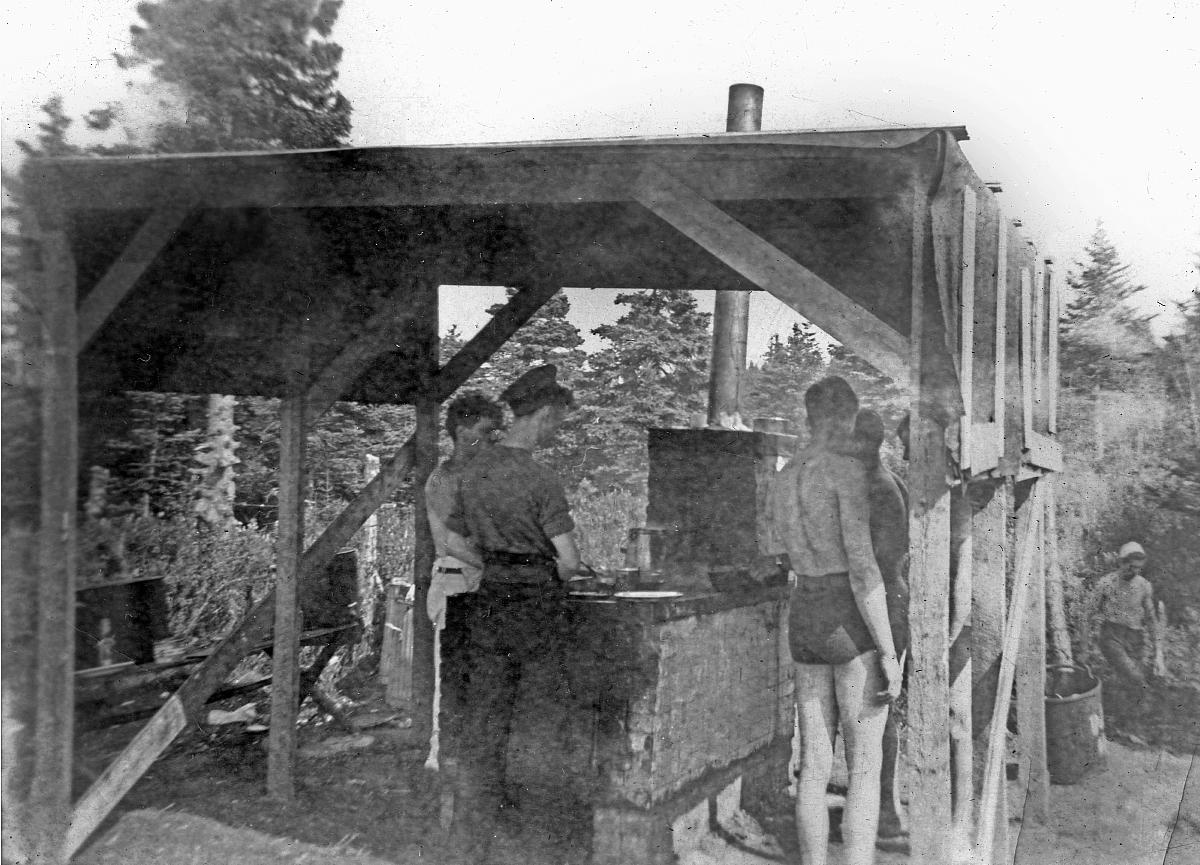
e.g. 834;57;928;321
950;481;974;859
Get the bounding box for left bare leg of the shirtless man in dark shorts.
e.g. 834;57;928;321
796;663;838;865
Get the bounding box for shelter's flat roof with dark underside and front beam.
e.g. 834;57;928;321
32;126;967;402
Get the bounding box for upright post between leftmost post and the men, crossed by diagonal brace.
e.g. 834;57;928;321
266;389;307;801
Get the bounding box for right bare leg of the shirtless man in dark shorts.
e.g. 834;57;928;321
834;651;888;865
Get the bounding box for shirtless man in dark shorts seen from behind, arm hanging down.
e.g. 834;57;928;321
774;377;900;865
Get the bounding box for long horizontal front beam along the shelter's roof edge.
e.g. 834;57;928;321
41;146;911;210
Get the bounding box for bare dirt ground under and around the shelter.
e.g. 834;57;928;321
78;683;1200;865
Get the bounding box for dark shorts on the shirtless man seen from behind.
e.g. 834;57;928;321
787;573;875;663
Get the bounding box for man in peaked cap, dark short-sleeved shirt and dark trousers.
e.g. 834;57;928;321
443;366;580;863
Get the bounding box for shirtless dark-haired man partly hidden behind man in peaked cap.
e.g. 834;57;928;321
425;391;504;769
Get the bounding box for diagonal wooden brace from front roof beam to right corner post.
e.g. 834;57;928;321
635;169;908;384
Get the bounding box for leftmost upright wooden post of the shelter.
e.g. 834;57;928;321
26;206;79;863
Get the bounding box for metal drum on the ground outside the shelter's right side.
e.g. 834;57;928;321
1045;663;1108;783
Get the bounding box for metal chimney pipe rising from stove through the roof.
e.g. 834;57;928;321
708;84;763;430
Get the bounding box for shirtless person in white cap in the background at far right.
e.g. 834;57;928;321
1097;541;1165;686
